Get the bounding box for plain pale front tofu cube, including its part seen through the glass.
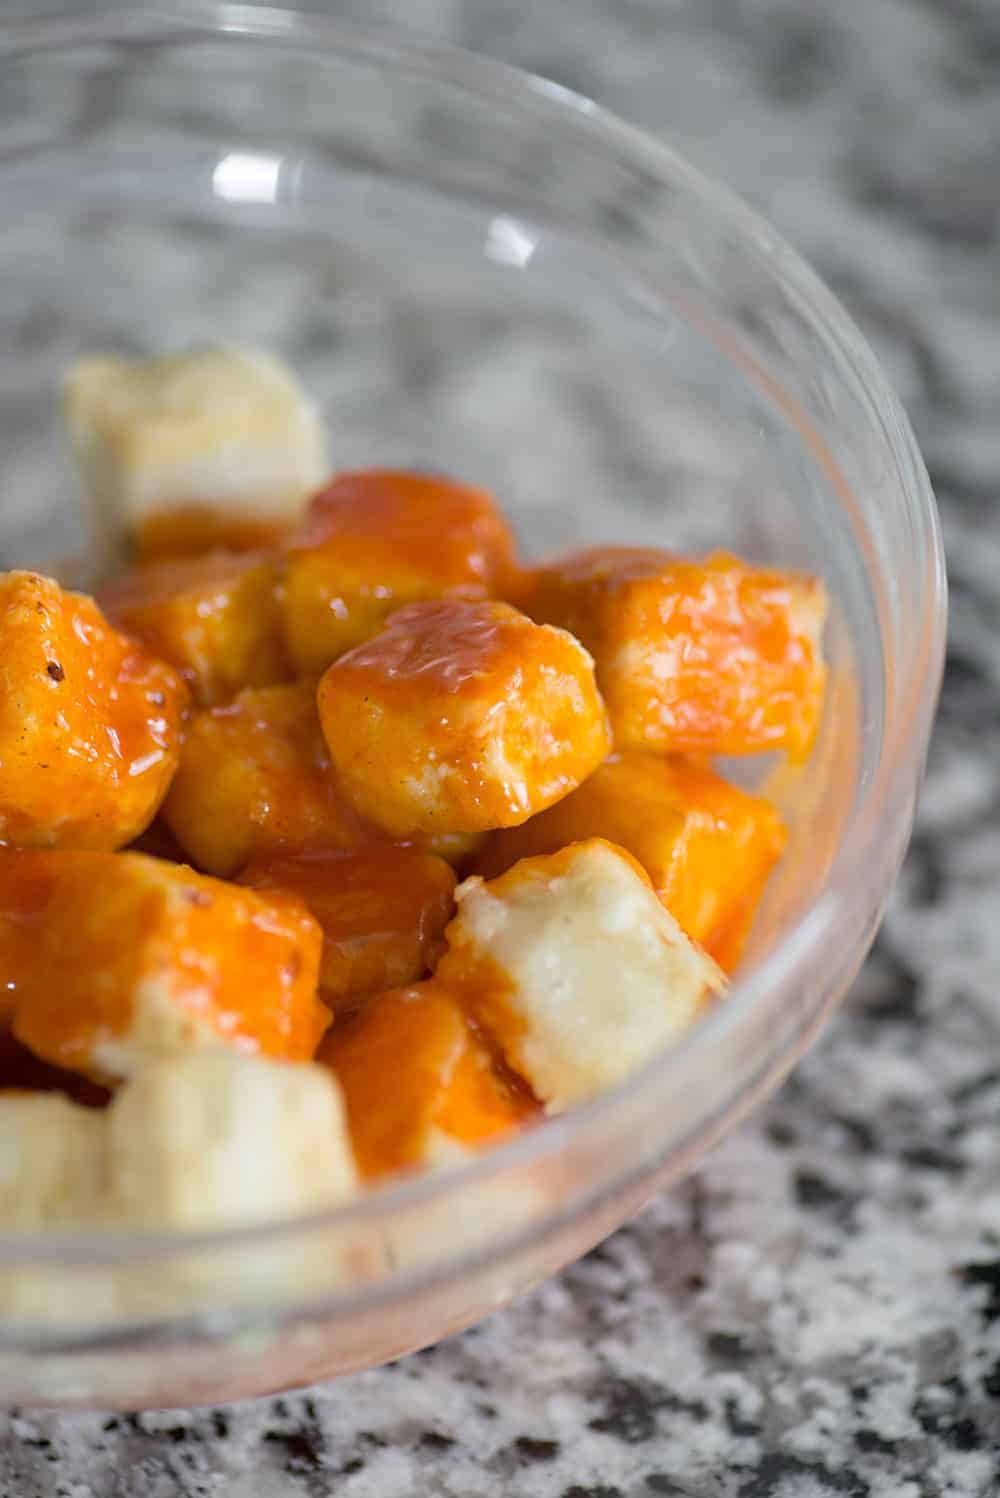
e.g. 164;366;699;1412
108;1052;372;1315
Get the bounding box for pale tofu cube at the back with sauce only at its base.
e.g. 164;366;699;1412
63;346;328;572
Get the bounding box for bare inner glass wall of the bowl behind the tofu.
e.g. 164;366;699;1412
0;26;880;956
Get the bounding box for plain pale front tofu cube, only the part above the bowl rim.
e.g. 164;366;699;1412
108;1053;358;1230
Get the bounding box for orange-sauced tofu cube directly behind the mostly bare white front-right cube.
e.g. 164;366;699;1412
476;749;786;972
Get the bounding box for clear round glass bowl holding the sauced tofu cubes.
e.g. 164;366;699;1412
0;4;945;1408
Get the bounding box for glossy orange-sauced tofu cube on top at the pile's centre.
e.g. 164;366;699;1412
319;599;609;839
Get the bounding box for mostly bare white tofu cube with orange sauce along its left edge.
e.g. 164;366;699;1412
437;839;725;1113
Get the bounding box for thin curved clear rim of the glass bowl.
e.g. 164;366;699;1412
0;0;946;1308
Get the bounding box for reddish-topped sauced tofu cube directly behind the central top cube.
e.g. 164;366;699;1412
284;472;513;676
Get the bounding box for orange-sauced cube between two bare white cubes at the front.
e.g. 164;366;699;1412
317;980;539;1180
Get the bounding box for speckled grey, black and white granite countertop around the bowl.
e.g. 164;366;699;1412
0;0;1000;1498
